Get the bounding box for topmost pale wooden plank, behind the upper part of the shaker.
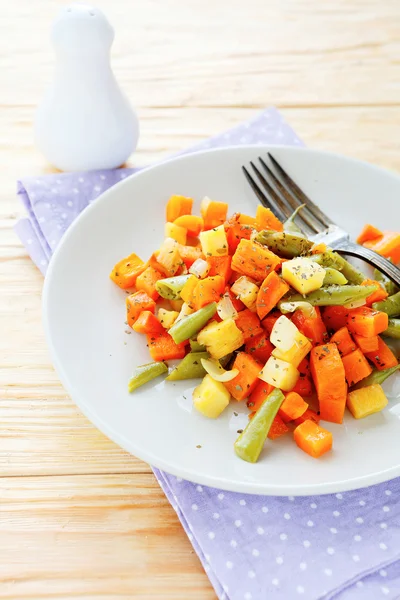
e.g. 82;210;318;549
1;0;400;110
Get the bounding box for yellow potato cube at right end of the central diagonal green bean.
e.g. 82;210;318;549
197;319;244;360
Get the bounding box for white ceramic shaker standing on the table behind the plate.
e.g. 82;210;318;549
35;4;139;171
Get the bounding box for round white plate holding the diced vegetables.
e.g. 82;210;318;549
44;146;400;495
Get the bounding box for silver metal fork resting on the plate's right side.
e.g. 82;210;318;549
242;152;400;286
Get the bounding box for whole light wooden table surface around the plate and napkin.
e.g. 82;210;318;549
0;0;400;600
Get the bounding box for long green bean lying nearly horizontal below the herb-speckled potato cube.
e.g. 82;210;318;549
285;285;376;306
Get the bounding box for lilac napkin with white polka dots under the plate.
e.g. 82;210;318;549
16;108;400;600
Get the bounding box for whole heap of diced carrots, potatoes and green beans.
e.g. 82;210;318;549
110;196;400;463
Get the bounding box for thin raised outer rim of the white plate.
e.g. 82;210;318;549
42;144;400;497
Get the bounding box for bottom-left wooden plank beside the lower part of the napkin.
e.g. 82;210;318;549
0;474;215;600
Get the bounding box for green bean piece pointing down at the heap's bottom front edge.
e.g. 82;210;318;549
234;389;285;463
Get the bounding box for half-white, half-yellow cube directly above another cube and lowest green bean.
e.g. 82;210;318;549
270;316;312;367
